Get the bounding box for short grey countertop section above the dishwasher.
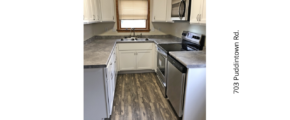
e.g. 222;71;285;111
169;51;206;68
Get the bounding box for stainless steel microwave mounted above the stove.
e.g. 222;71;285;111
171;0;191;21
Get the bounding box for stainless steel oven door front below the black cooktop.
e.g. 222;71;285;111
157;47;167;97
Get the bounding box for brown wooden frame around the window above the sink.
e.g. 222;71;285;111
116;0;150;32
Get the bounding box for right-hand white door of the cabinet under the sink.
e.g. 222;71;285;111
137;50;152;70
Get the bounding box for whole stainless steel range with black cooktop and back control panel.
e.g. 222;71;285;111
156;31;205;97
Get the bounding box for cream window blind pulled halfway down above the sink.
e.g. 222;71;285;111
118;0;148;20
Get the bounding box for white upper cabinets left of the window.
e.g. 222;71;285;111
83;0;115;24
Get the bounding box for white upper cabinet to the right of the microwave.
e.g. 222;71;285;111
190;0;206;25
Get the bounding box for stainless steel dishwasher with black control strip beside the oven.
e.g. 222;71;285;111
167;56;187;117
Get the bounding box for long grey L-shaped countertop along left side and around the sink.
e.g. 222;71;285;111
84;36;181;68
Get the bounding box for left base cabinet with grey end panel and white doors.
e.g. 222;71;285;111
84;47;118;120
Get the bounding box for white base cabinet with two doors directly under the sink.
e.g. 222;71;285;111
117;43;155;71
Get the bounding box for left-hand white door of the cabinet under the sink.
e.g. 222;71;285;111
119;51;136;70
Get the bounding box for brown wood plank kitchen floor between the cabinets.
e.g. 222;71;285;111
111;73;177;120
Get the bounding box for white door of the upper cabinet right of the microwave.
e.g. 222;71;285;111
190;0;203;24
